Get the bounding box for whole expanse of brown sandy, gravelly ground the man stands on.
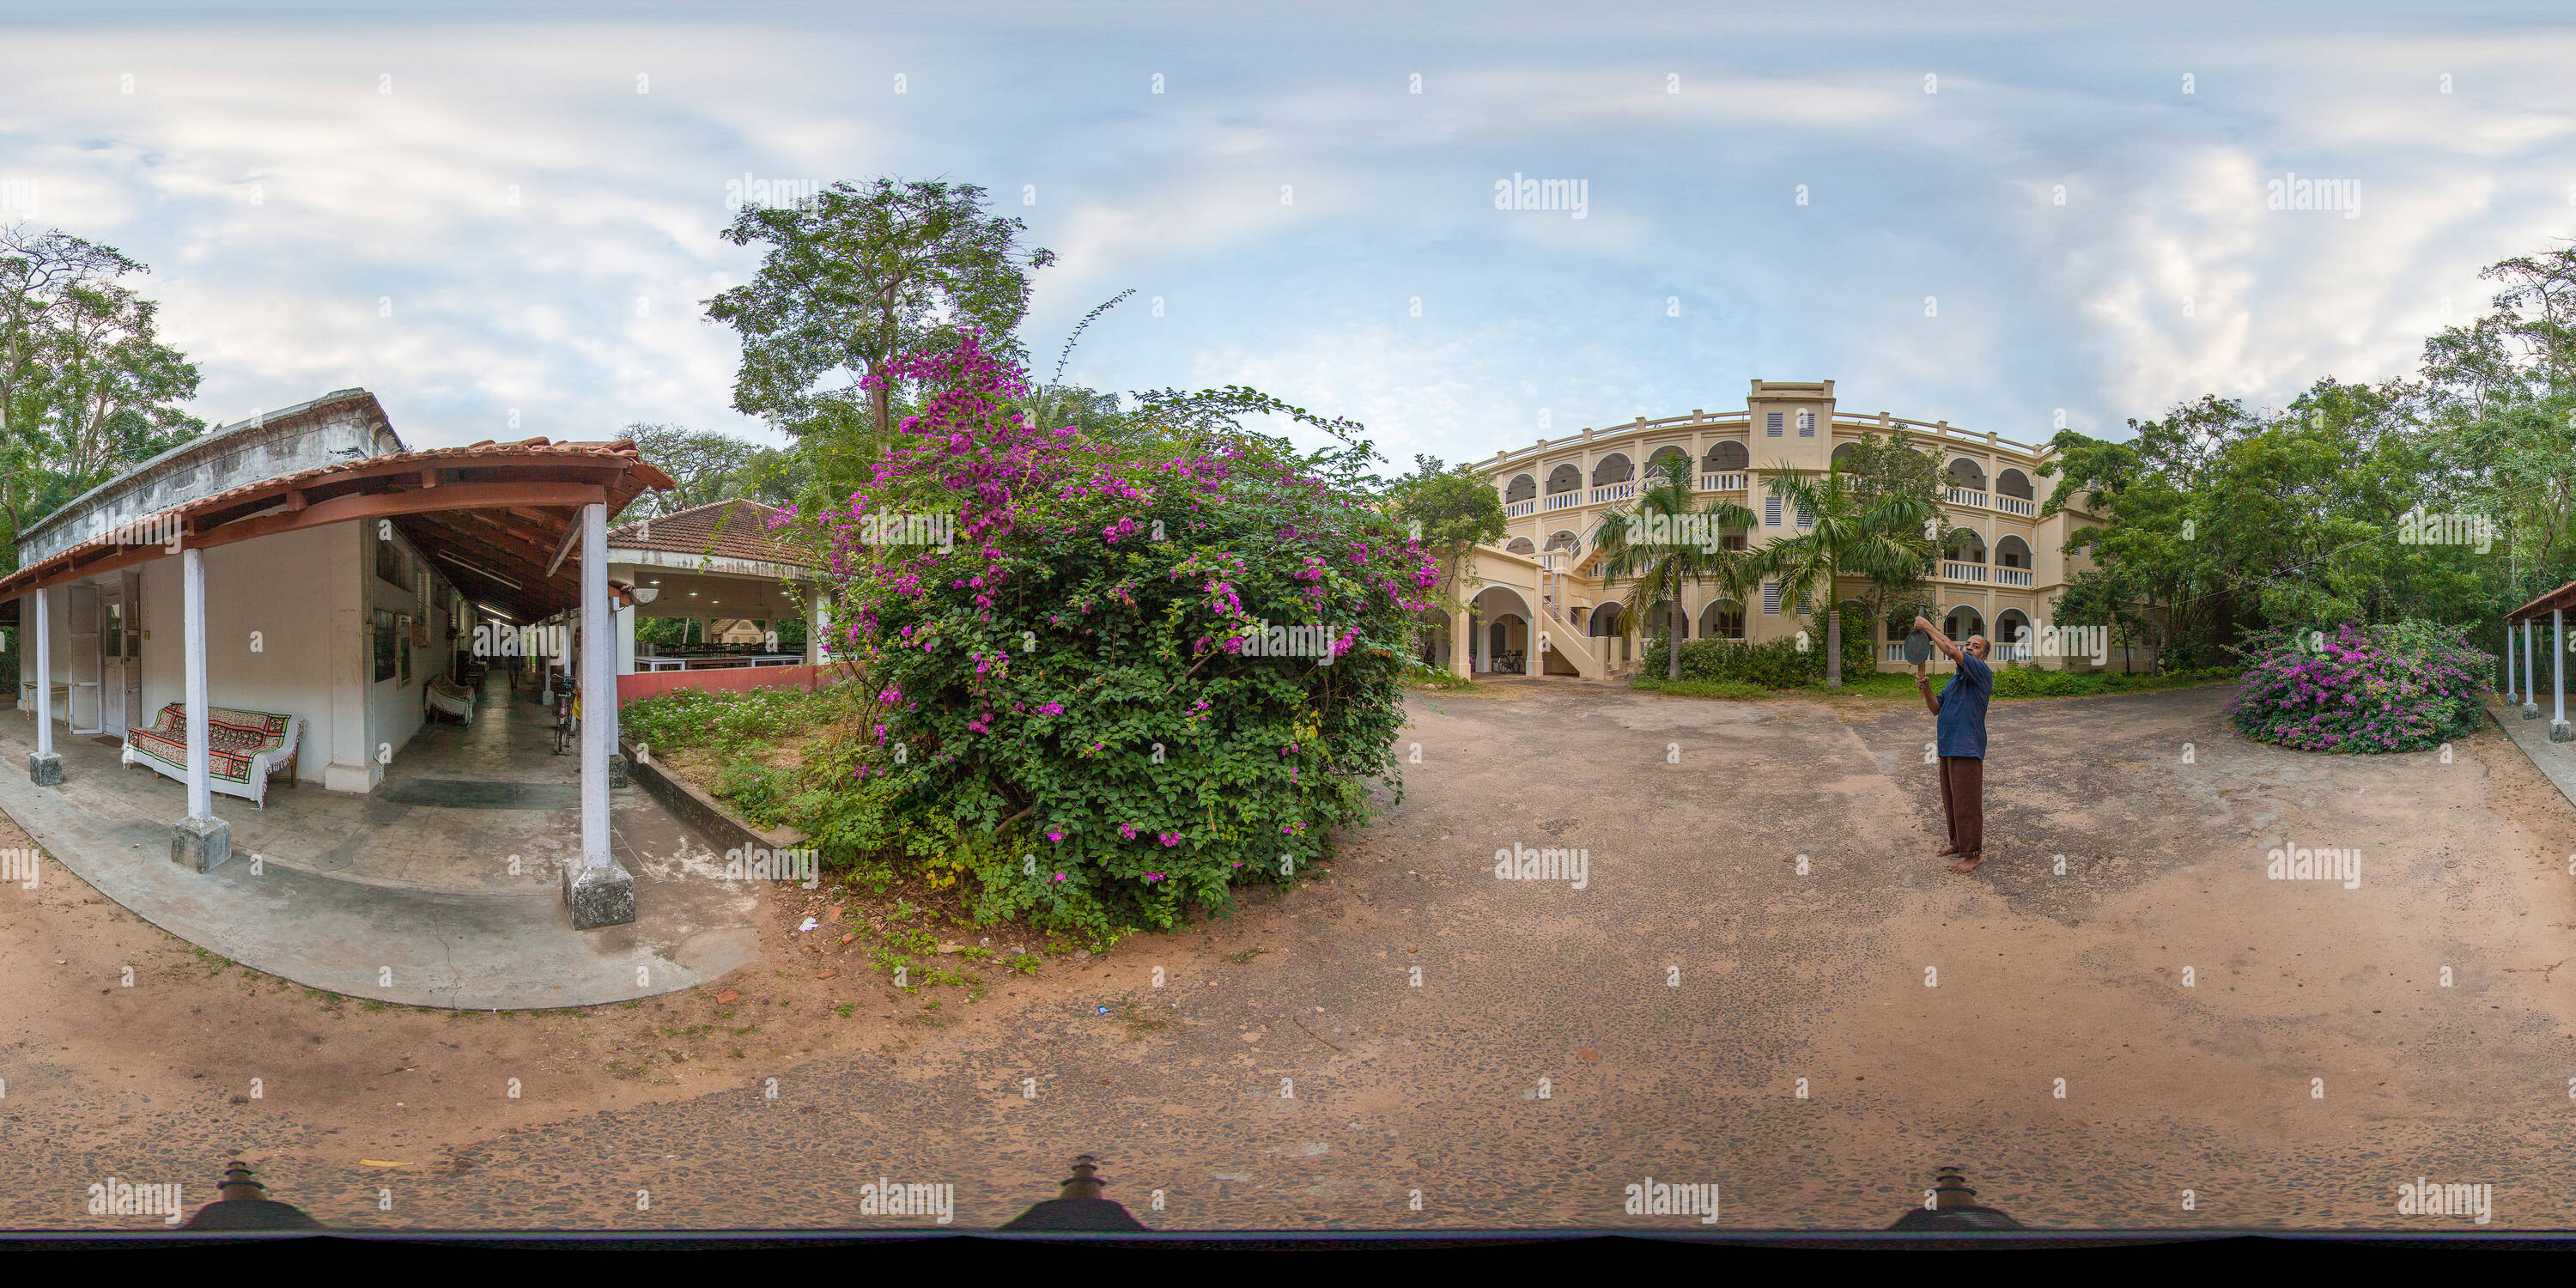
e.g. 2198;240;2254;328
0;683;2576;1229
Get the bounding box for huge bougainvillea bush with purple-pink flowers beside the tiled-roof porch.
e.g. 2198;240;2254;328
773;337;1435;940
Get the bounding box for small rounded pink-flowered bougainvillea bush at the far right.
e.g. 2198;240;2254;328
2228;621;2496;752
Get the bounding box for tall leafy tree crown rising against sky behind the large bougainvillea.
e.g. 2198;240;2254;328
706;175;1056;456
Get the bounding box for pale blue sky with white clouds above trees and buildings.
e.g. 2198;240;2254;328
0;0;2576;461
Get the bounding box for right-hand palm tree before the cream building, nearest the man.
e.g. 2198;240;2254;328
1752;464;1940;688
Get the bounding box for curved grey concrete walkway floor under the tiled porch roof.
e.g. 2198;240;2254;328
0;672;760;1010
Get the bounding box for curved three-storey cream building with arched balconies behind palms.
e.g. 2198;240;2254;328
1425;379;2148;677
